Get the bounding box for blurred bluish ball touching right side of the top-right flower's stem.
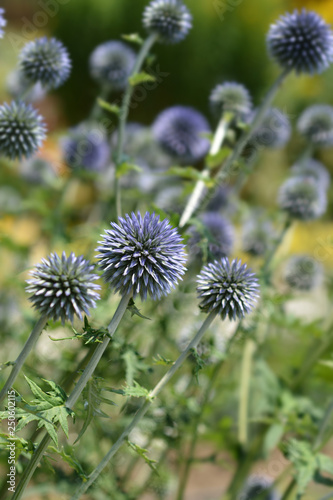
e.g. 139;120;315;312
250;108;291;149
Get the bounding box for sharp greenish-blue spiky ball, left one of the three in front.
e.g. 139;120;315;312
26;252;101;323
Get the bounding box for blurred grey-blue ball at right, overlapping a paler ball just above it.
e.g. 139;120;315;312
278;177;327;221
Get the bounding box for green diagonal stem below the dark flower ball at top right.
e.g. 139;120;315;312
217;69;290;187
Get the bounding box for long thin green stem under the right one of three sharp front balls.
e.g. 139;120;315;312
71;312;216;500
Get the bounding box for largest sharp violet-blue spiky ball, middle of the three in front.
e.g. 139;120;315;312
97;212;186;300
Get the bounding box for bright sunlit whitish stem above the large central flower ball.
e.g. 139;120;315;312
179;115;232;227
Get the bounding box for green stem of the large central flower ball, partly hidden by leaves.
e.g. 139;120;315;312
12;294;132;500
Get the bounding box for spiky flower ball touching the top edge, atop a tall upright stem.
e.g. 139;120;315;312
143;0;192;44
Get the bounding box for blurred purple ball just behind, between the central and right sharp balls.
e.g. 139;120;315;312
188;212;234;260
